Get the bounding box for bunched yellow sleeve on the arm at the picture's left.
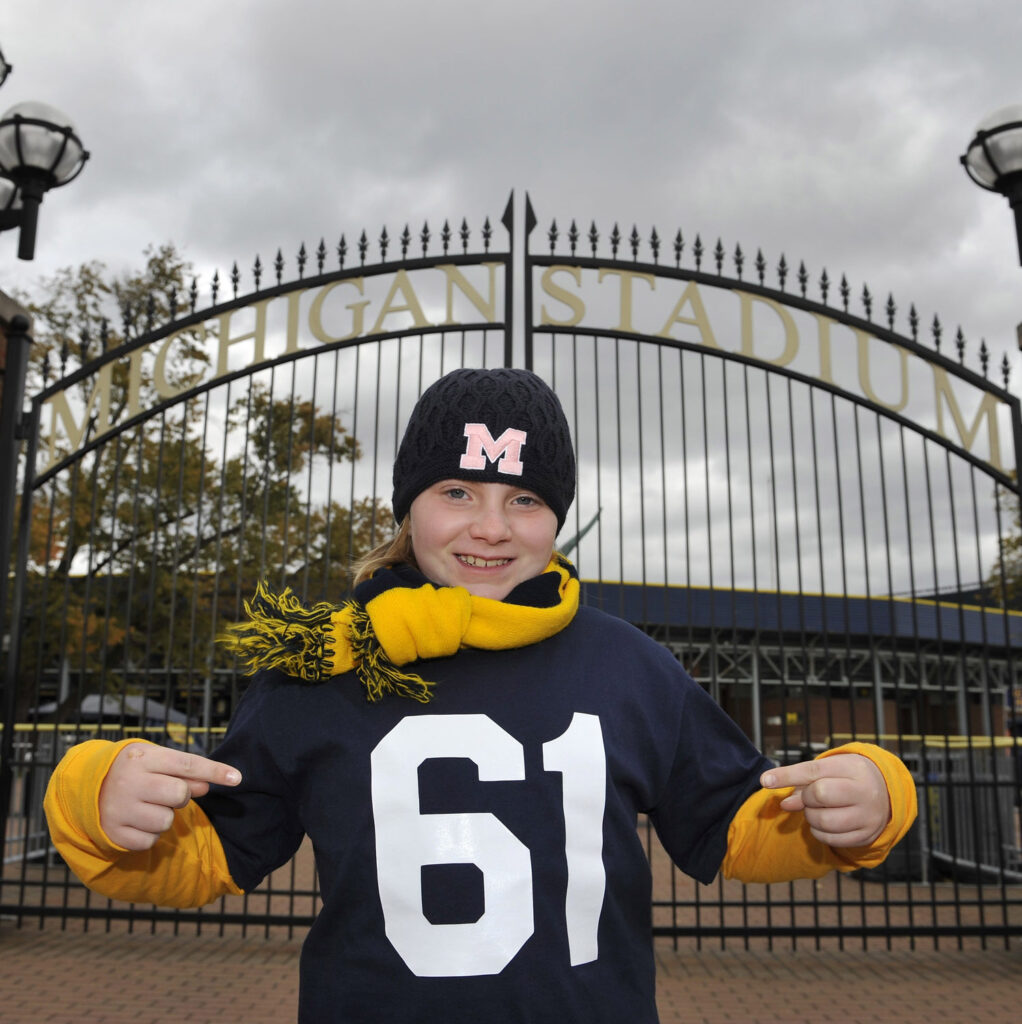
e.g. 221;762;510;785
43;739;242;907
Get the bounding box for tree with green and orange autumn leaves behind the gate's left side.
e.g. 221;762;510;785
12;246;389;717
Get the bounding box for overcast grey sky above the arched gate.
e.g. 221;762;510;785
0;0;1022;387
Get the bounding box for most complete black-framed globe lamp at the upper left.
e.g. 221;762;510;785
0;100;89;259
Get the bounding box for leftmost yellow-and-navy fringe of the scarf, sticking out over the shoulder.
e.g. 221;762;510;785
216;581;337;683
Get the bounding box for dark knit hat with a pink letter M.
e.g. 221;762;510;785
393;370;574;529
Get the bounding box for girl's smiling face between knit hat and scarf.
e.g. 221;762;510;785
410;480;557;601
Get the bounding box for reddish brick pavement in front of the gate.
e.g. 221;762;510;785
0;923;1022;1024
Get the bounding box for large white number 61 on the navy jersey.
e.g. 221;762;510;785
372;713;606;977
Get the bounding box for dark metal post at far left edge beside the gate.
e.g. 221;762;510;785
0;313;32;848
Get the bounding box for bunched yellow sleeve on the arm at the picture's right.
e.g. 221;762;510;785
721;743;918;882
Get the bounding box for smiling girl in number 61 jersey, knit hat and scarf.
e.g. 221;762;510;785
46;370;915;1024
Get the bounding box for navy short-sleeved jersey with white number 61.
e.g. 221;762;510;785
201;607;768;1024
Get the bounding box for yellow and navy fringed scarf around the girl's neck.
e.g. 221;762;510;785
217;555;579;702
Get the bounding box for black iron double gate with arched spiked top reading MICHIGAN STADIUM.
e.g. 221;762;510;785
0;192;1022;942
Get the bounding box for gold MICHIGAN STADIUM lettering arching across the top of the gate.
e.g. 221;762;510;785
34;261;1005;471
